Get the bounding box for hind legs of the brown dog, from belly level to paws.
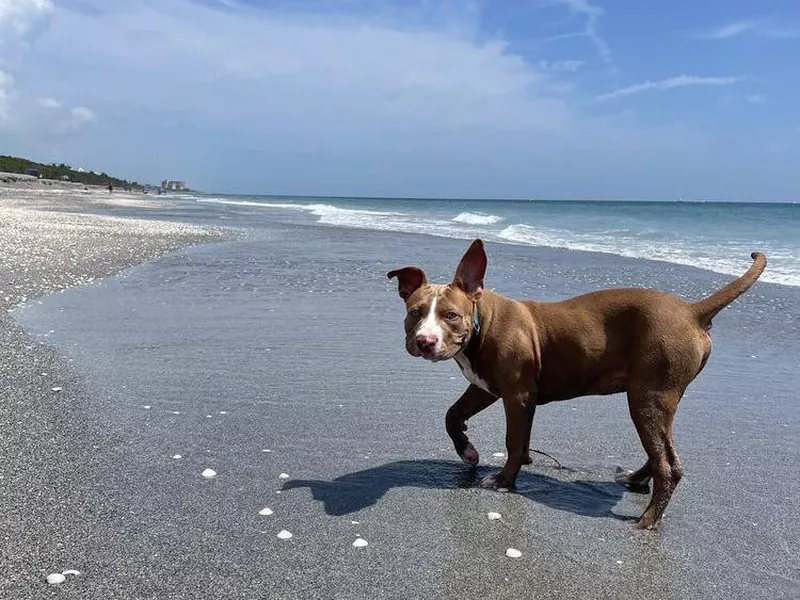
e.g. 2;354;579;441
628;388;683;529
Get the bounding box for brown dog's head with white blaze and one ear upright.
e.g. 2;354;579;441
387;240;486;361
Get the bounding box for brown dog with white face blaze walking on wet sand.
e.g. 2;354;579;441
388;240;767;529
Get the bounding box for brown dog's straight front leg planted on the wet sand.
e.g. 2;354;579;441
481;390;536;488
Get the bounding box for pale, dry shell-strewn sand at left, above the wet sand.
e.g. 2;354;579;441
0;178;225;310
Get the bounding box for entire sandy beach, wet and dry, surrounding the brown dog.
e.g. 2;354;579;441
0;188;800;599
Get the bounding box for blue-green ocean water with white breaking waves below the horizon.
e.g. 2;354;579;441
180;195;800;287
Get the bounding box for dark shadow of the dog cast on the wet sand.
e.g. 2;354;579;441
283;460;632;520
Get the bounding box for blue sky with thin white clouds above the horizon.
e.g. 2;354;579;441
0;0;800;201
